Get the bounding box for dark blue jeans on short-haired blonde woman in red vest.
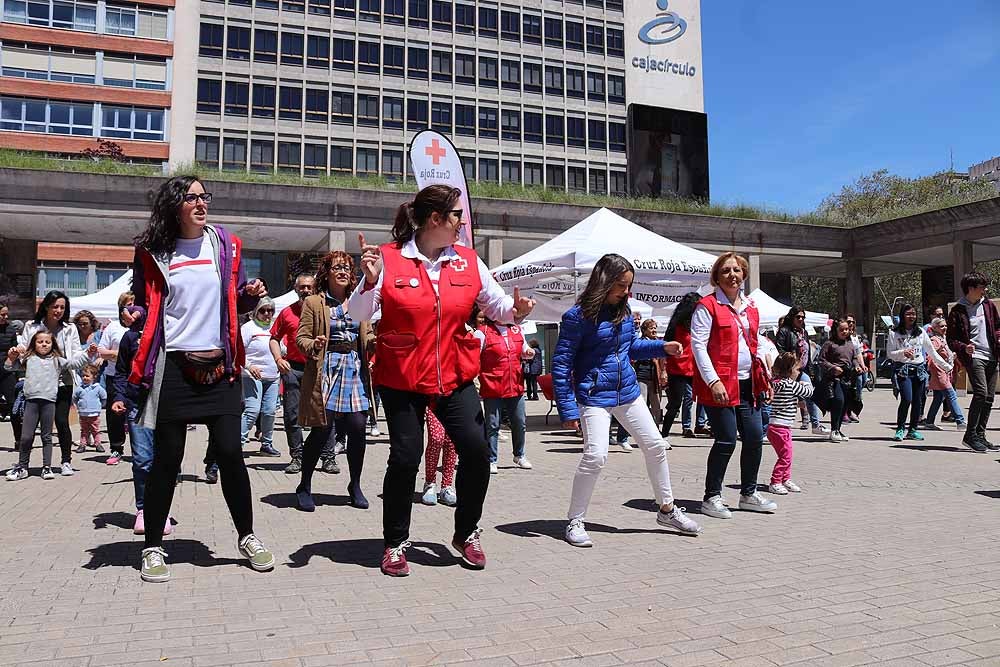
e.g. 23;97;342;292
704;380;764;500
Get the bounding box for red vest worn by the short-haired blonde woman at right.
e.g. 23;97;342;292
692;294;766;407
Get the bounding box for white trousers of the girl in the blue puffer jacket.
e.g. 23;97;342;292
567;396;674;521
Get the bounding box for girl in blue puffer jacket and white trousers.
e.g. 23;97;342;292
552;253;701;547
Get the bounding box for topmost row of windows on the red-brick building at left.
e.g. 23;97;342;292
2;0;168;39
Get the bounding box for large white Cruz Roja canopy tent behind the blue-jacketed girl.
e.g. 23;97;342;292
493;208;715;322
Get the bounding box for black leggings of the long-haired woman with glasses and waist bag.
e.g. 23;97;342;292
143;415;253;548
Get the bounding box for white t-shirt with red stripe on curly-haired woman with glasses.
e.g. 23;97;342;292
163;235;223;352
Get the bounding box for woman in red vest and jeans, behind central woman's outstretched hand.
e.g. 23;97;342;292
473;318;535;474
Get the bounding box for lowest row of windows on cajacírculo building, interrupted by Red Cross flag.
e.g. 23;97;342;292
195;135;627;194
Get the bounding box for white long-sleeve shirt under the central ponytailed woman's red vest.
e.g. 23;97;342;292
347;239;516;324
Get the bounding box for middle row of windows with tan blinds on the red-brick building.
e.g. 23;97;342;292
0;42;168;90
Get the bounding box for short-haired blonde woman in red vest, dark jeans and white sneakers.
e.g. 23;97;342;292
691;252;778;519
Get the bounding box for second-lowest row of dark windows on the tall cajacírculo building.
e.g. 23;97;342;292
198;79;625;152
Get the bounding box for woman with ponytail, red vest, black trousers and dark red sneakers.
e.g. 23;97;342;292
348;185;535;577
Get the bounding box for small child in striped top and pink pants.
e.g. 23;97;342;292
767;352;813;496
